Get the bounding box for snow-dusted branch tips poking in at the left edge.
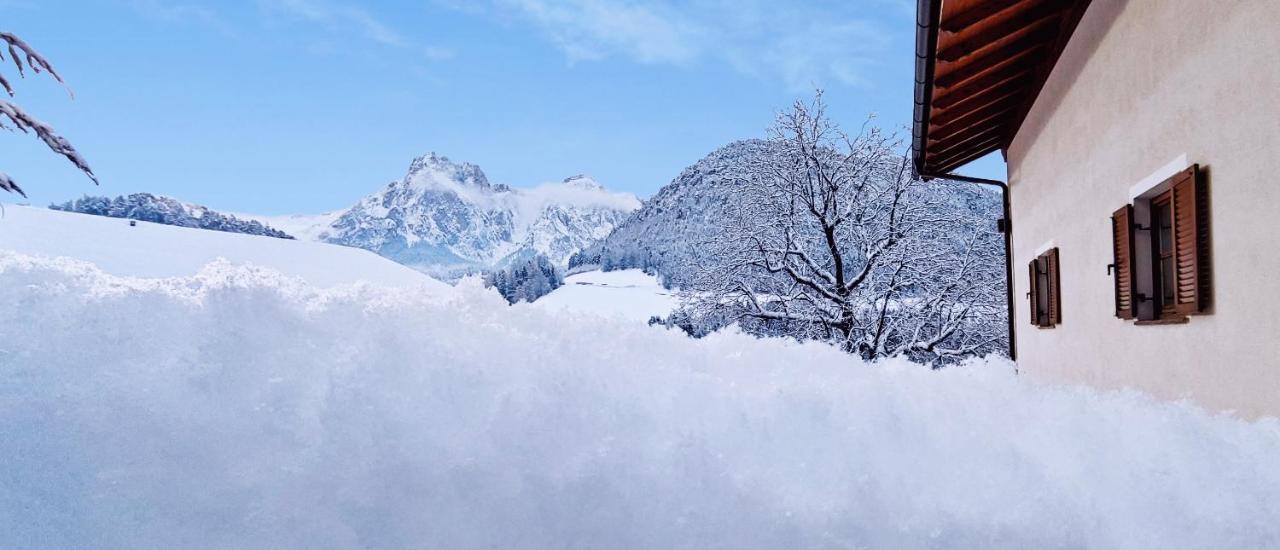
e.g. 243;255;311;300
0;32;97;197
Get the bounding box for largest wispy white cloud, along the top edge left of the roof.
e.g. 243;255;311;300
460;0;914;88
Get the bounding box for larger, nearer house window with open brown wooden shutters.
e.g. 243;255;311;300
1108;165;1210;324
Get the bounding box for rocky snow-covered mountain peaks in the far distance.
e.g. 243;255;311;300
255;152;641;279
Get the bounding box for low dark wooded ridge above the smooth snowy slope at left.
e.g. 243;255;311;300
49;193;293;239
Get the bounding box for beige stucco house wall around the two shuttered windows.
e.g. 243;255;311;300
1009;0;1280;418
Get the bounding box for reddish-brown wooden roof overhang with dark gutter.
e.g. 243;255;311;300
911;0;1089;177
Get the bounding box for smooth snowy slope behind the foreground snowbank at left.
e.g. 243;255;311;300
0;206;449;292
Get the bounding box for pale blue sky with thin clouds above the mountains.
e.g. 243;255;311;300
0;0;1004;214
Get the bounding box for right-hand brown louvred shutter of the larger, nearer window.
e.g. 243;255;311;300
1170;166;1208;315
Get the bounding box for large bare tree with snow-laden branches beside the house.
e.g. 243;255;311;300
681;92;1007;362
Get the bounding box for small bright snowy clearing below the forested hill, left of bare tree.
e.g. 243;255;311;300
527;270;680;322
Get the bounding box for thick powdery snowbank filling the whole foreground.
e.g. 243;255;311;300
0;253;1280;549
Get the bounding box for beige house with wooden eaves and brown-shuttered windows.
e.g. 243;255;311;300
914;0;1280;417
